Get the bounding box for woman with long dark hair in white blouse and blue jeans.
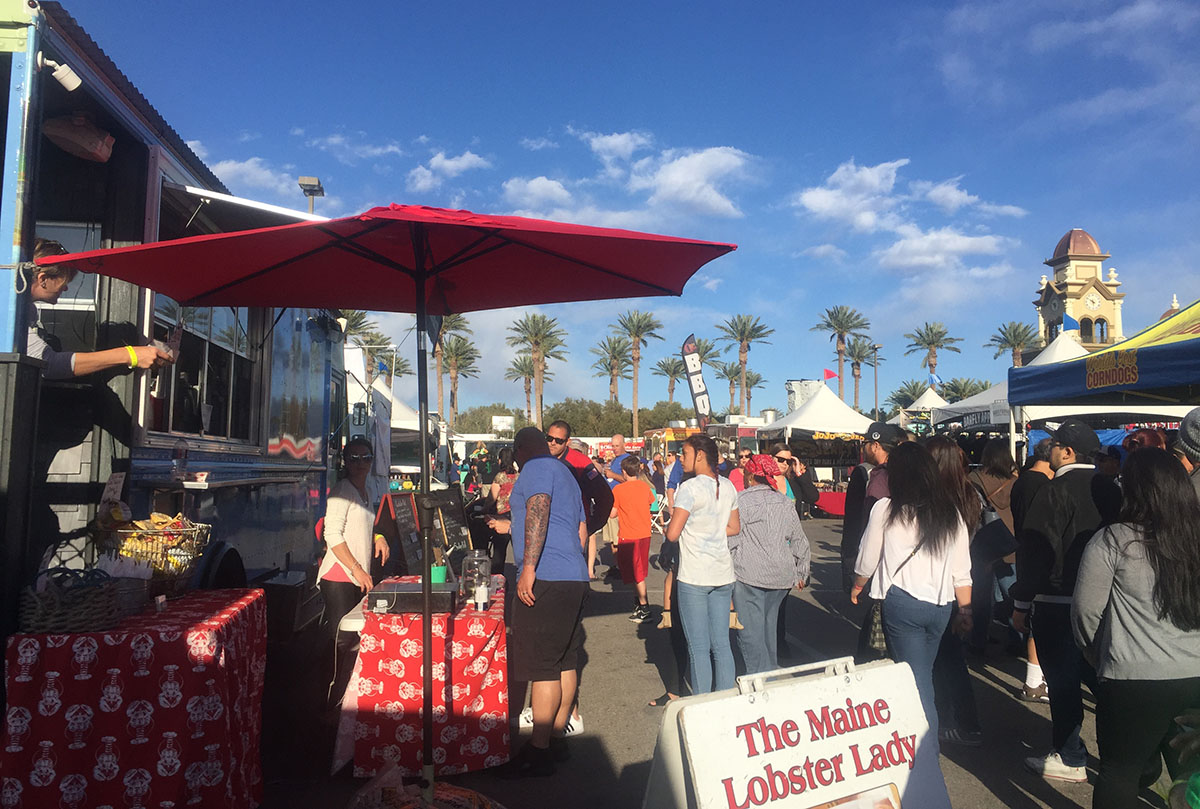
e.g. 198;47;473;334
851;442;971;739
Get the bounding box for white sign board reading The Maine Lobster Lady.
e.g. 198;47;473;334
679;664;950;809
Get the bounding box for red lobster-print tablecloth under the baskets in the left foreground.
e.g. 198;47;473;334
0;589;266;809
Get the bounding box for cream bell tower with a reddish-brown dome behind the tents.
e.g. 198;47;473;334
1033;228;1124;350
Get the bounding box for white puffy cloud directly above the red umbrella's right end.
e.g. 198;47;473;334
629;146;750;218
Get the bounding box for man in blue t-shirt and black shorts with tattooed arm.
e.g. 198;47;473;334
488;427;589;778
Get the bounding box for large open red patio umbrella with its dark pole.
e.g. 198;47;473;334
37;205;737;784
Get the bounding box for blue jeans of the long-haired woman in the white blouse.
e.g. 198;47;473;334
883;585;950;734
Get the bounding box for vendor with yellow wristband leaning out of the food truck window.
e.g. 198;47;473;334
25;239;172;379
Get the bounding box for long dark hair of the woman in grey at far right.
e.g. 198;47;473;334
1120;447;1200;631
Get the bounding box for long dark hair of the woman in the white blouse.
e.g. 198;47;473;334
884;442;962;555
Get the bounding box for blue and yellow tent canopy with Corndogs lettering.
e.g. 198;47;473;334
1008;296;1200;405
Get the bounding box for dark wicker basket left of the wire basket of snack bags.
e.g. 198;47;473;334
18;568;121;634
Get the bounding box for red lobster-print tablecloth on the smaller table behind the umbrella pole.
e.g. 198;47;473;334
335;576;509;777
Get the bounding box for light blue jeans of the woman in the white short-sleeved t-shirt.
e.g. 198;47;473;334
676;581;733;694
